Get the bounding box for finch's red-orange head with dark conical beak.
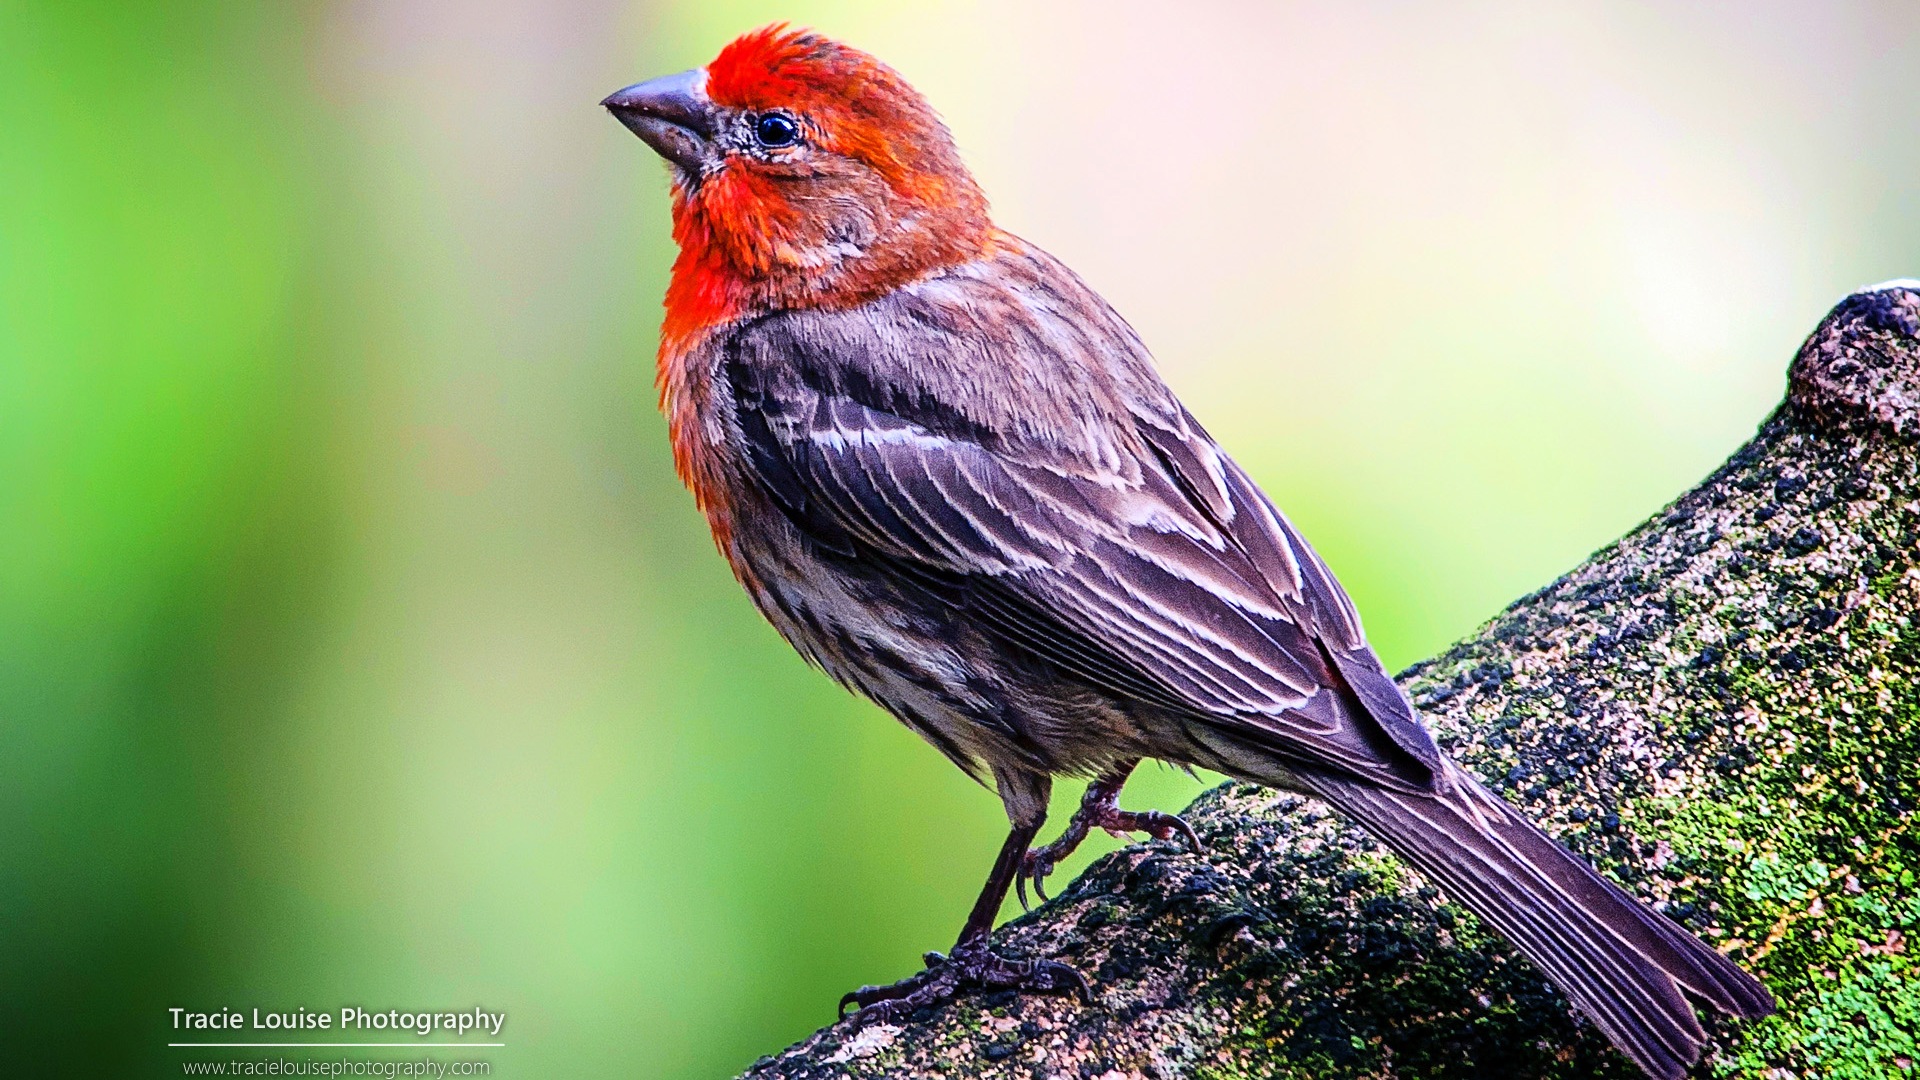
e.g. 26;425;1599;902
601;25;991;319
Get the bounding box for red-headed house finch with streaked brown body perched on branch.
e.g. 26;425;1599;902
603;27;1772;1078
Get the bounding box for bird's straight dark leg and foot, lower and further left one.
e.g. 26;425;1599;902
841;780;1089;1024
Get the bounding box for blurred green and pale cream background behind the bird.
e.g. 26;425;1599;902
0;0;1920;1078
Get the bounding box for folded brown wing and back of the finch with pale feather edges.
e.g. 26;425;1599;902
720;239;1440;788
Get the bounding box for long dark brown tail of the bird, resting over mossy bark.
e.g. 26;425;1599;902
1292;763;1774;1080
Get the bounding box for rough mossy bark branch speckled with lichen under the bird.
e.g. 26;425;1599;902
749;282;1920;1080
